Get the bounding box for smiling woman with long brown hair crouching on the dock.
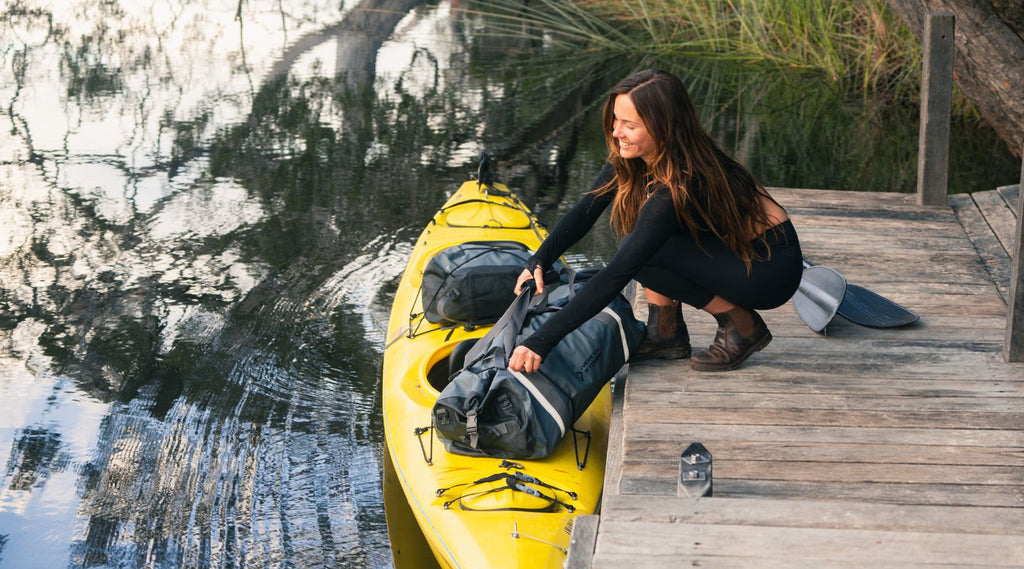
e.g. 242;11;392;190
509;70;803;373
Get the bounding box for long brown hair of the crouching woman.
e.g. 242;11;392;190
594;70;771;269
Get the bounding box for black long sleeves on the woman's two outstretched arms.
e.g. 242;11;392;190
521;164;696;357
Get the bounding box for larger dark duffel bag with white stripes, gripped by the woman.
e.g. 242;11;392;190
432;270;644;459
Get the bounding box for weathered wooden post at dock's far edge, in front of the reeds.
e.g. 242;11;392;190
918;12;956;206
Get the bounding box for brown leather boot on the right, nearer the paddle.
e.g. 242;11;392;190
690;306;771;371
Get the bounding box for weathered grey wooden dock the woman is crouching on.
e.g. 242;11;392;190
566;186;1024;569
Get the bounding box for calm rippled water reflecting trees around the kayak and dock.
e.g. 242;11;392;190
0;0;1019;568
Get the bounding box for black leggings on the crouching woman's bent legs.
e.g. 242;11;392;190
626;220;804;310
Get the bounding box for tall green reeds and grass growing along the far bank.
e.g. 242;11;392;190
467;0;980;114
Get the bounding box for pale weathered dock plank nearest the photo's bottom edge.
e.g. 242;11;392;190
595;521;1024;567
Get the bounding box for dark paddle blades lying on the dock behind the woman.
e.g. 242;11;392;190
793;260;920;332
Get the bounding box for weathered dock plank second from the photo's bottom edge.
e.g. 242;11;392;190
603;496;1024;535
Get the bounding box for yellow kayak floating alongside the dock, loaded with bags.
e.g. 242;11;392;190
383;170;611;569
